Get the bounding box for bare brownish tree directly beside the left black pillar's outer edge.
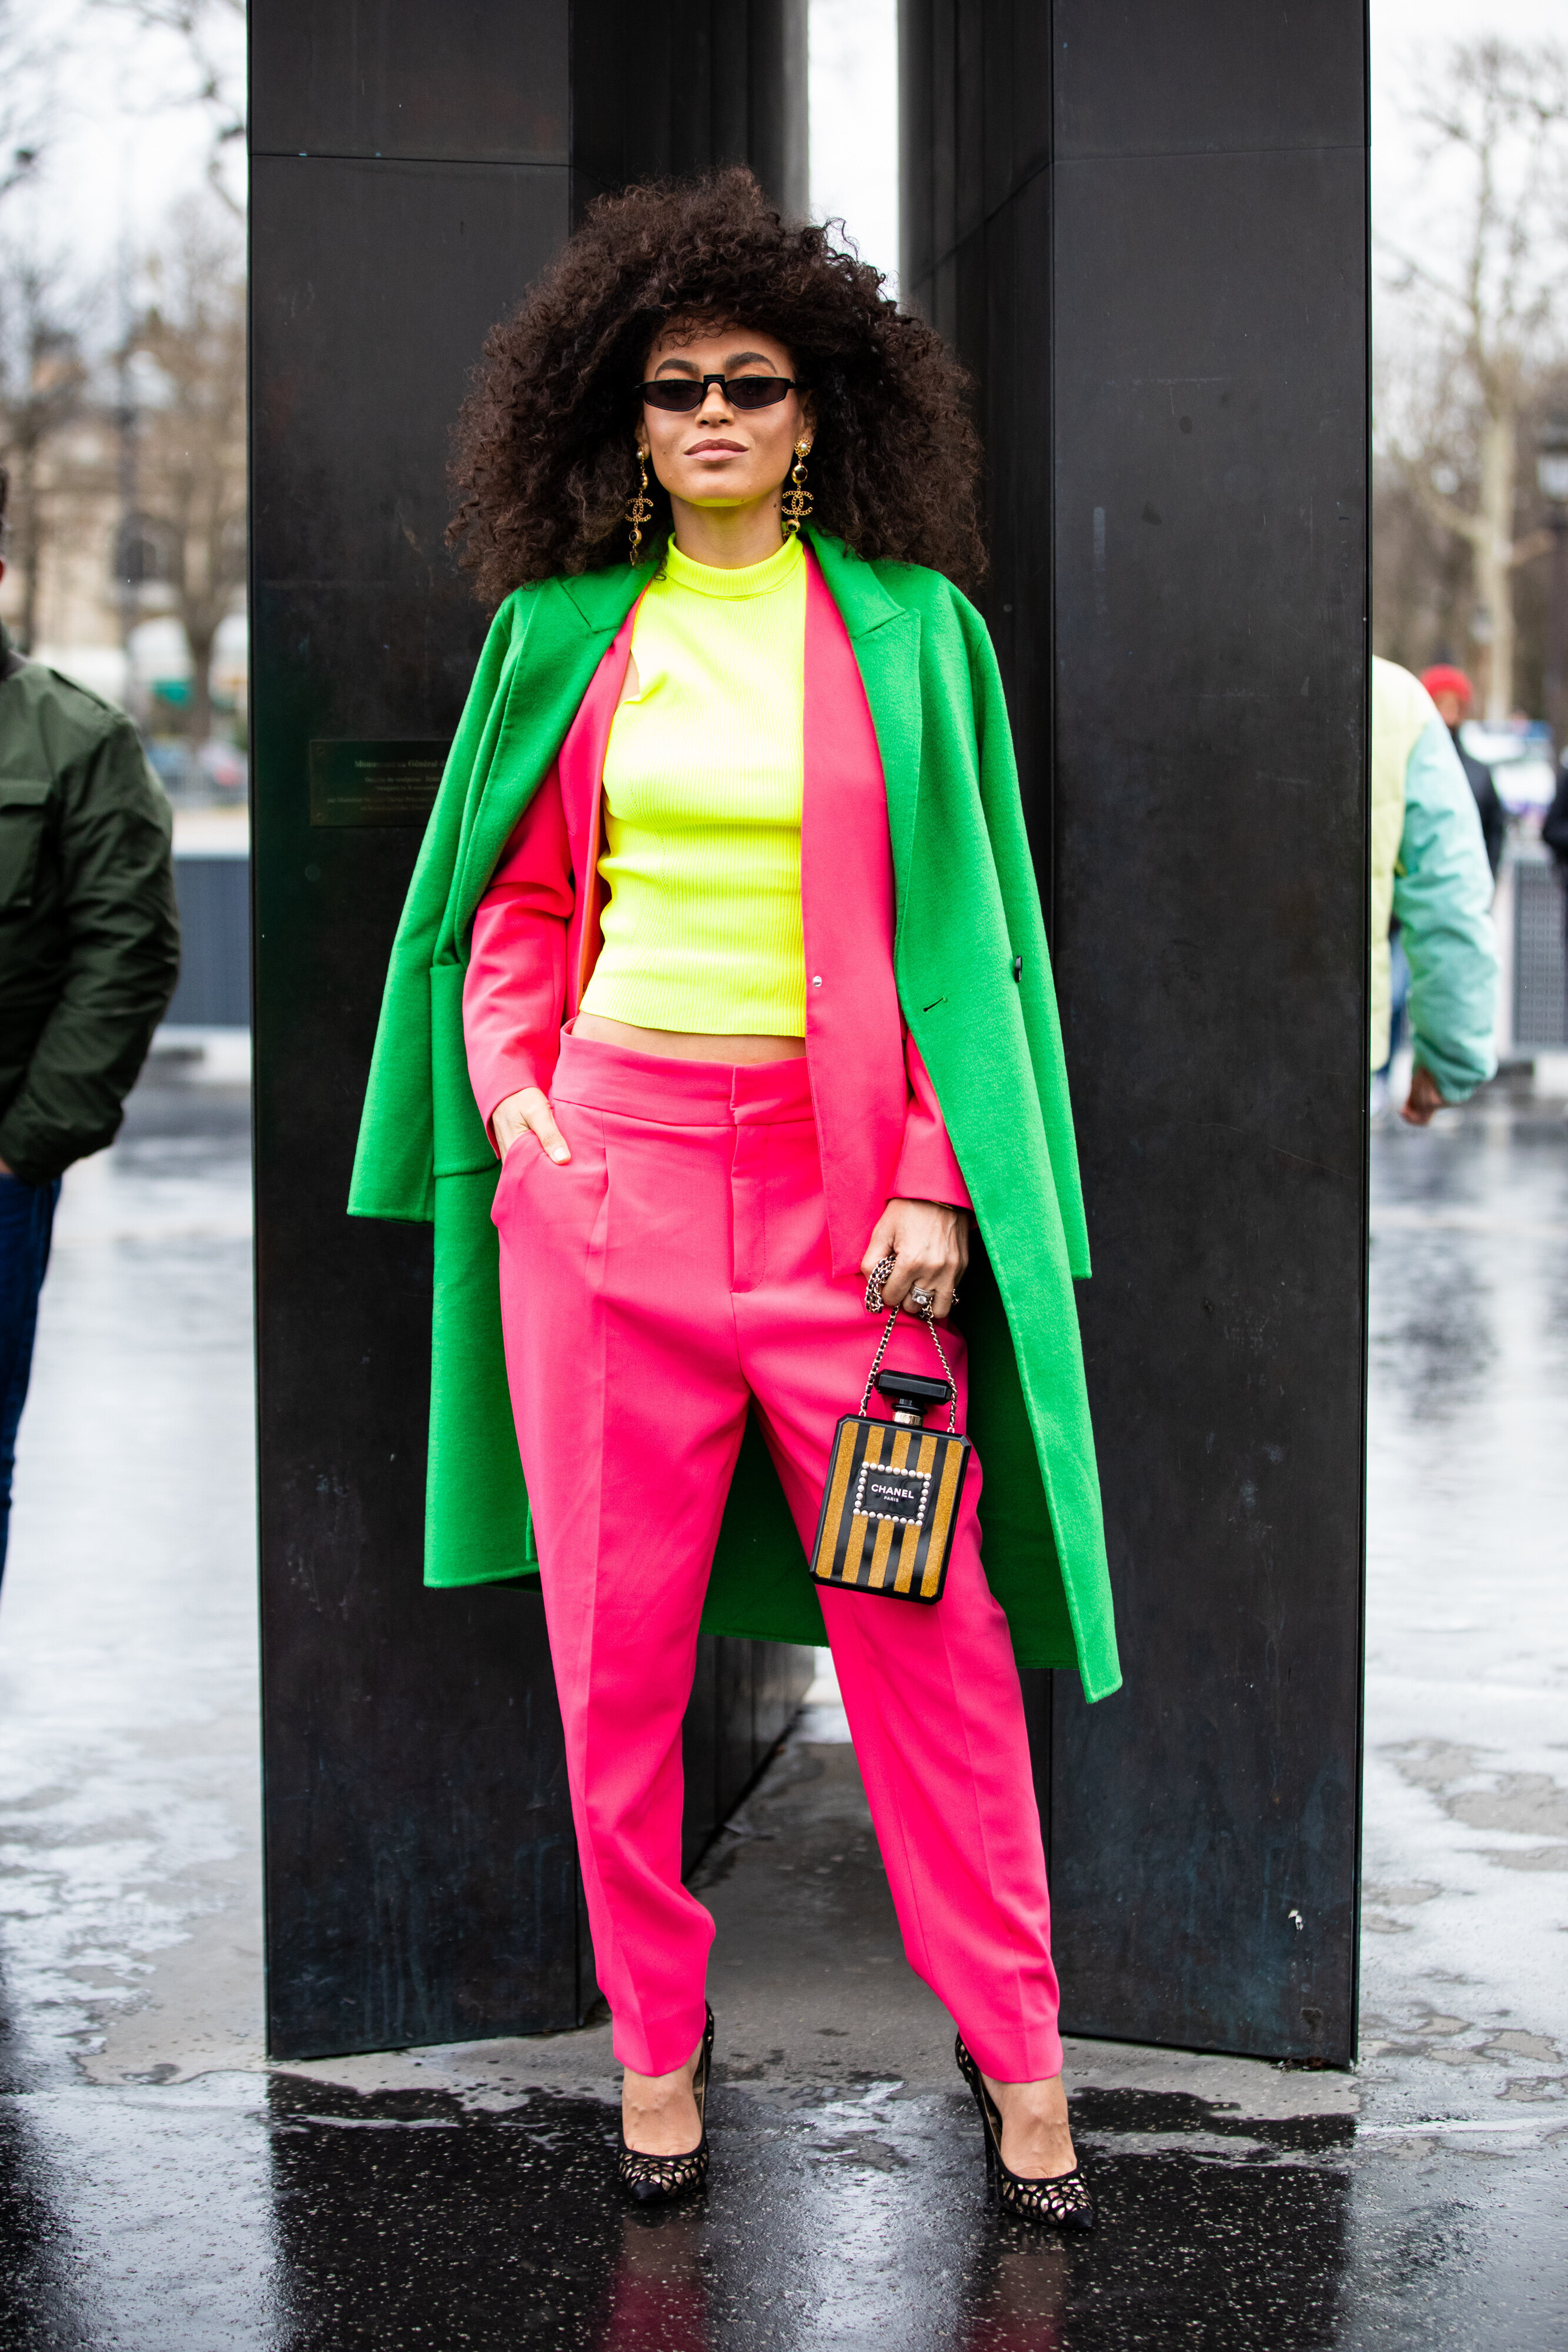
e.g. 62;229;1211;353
132;200;245;748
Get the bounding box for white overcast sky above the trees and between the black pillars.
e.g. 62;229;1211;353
7;0;1568;310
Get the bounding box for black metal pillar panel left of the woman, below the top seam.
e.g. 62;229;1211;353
252;158;579;2056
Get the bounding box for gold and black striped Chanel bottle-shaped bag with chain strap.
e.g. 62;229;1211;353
811;1258;973;1602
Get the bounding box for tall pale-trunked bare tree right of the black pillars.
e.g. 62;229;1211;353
1382;40;1568;717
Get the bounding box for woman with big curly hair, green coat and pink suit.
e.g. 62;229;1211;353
353;172;1119;2227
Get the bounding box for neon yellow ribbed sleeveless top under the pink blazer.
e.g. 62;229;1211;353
583;539;806;1037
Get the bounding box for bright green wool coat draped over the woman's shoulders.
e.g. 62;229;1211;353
350;532;1121;1698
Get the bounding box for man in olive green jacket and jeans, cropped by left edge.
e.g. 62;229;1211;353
0;473;179;1569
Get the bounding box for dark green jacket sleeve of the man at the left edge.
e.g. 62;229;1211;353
0;717;179;1183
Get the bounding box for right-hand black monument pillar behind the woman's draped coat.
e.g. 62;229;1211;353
900;0;1368;2063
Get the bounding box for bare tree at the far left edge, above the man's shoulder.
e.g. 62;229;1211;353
0;254;87;652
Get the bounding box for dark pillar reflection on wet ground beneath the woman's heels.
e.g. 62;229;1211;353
257;2077;1352;2352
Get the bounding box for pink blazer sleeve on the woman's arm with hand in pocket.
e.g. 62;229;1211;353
463;767;576;1148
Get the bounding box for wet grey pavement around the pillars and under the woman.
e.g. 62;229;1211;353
0;1056;1568;2352
